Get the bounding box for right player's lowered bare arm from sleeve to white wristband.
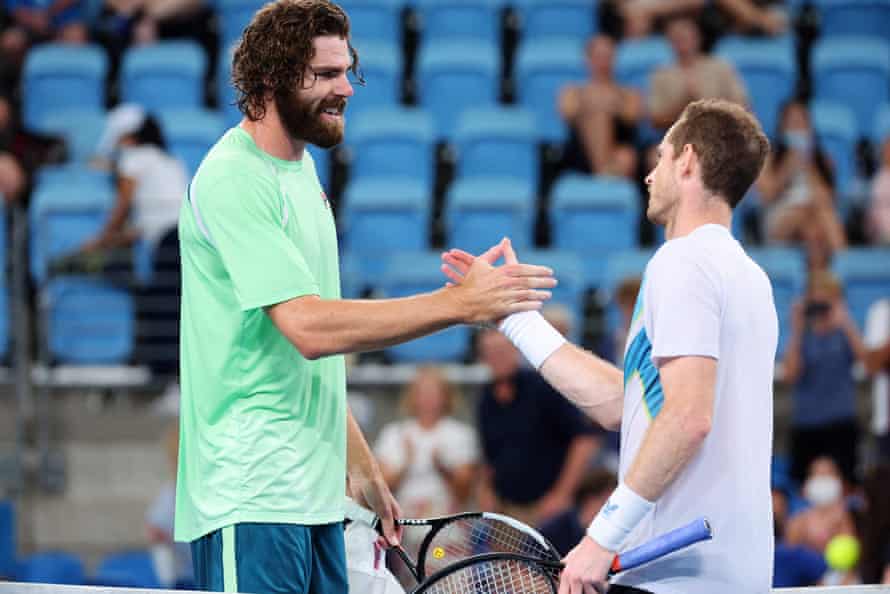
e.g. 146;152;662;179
625;357;717;501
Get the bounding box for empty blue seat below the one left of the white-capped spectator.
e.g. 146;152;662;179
42;276;134;365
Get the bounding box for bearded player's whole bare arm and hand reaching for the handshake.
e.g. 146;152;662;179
266;249;556;359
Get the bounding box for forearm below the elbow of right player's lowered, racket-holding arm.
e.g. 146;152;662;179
624;408;710;501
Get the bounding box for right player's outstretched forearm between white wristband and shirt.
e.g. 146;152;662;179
539;343;624;429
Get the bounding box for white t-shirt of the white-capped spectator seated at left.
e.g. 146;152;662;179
118;144;188;246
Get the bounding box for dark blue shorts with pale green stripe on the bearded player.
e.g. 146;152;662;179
192;522;349;594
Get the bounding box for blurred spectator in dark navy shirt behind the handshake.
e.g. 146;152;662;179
477;330;598;525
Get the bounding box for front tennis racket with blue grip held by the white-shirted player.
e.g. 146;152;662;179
413;518;713;594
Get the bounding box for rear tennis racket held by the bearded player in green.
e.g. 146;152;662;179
346;498;560;583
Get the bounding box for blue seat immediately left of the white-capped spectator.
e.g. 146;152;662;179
28;168;114;284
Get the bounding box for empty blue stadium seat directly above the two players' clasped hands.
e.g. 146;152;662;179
445;177;535;254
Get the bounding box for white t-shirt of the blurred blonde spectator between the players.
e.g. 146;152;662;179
374;417;479;517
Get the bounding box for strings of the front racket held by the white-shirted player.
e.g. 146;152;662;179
421;559;559;594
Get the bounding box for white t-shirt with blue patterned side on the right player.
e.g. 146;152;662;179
613;225;778;594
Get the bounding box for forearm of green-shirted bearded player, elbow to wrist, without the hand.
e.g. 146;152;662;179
268;288;462;359
